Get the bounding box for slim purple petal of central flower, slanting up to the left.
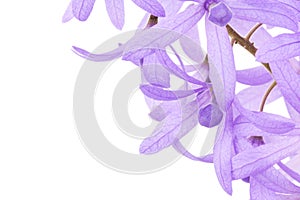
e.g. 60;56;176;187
156;50;207;87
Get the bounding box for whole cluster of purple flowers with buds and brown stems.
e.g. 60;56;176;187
63;0;300;200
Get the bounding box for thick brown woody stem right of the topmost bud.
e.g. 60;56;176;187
226;25;272;73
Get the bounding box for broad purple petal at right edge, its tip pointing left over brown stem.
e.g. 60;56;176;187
256;33;300;63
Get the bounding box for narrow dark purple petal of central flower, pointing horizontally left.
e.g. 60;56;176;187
140;85;203;101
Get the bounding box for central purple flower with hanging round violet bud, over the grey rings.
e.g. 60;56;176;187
140;52;223;166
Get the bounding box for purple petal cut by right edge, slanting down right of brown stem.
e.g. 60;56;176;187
270;61;300;112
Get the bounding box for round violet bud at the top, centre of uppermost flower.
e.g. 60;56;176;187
208;2;232;26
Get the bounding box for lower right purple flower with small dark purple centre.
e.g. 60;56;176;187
232;101;300;199
